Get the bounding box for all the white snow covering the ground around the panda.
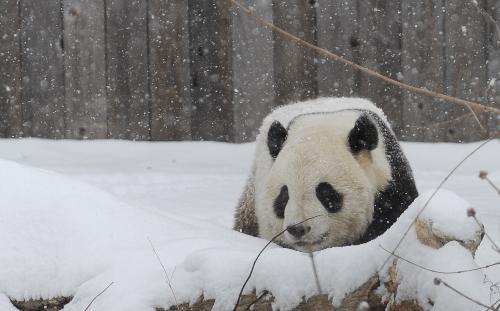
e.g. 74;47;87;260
0;139;500;310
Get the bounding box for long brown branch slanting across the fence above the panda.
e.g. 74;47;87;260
230;0;500;114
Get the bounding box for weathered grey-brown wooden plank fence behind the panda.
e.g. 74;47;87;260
0;0;500;142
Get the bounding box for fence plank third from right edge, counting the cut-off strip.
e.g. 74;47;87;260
401;0;451;141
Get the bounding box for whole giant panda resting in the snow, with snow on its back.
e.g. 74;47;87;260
234;98;418;252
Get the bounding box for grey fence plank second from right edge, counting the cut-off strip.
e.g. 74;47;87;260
441;0;488;142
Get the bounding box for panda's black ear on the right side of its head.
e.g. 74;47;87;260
348;114;378;154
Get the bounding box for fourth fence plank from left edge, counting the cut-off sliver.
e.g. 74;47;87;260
106;1;150;140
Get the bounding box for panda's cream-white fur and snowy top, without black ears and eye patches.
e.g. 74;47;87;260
254;98;391;251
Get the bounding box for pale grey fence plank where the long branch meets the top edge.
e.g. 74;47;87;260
232;0;274;142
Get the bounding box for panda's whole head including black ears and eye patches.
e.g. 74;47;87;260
256;110;391;251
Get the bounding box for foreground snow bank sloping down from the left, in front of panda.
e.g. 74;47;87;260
0;160;490;311
